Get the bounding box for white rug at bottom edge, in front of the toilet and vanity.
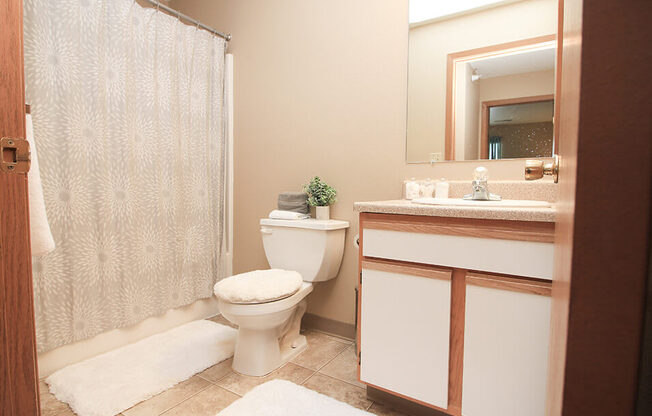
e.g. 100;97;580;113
218;380;371;416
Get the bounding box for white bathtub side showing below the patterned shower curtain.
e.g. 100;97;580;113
38;297;219;378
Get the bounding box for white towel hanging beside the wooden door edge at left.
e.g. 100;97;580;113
25;114;54;256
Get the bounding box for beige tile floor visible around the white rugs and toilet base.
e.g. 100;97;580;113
41;316;405;416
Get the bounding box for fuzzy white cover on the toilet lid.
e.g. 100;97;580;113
214;269;303;303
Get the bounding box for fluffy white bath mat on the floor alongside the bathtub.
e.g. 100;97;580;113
45;320;237;416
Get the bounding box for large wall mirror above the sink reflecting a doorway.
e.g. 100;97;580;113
406;0;557;163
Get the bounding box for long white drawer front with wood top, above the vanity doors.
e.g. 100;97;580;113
362;228;554;279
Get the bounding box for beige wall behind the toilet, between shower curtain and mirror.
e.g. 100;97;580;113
172;0;556;323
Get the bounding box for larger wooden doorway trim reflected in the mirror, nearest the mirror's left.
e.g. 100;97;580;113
444;34;557;160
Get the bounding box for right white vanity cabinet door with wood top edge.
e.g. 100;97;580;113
462;273;550;416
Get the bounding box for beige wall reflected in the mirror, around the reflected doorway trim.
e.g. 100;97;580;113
407;0;557;161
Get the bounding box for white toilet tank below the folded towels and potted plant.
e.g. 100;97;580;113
260;218;349;282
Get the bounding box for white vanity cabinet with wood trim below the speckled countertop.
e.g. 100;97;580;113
358;212;554;416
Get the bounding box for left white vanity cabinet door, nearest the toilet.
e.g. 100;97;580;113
360;262;451;409
